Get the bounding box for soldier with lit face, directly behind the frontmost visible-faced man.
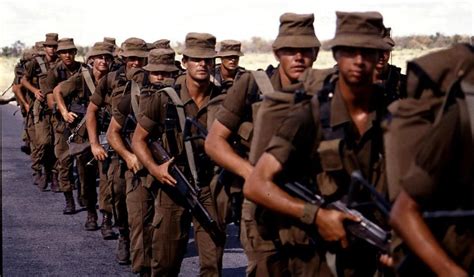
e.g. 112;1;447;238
206;13;321;276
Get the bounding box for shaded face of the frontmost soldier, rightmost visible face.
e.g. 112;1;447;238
334;47;379;86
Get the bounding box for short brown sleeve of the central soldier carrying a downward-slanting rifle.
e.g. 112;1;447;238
137;92;163;133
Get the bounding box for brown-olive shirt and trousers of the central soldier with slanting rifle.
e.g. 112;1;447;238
137;76;224;276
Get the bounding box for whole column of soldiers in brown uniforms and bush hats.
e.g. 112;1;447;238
10;12;474;276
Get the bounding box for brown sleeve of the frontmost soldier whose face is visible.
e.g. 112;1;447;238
265;101;319;165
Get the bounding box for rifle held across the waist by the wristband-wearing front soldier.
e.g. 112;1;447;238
283;178;390;253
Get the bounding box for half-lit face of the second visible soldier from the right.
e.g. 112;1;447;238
275;48;319;83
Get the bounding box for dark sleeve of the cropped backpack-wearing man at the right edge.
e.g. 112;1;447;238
401;105;465;205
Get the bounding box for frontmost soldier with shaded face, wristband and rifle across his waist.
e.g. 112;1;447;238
244;12;388;276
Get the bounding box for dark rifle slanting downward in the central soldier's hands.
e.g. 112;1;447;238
148;141;222;242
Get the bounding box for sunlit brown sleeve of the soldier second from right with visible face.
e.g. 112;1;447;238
216;73;254;132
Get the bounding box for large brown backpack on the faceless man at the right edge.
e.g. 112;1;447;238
384;44;474;200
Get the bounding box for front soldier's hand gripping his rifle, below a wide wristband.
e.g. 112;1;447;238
315;208;360;248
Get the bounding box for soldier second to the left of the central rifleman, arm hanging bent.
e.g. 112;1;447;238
86;38;147;264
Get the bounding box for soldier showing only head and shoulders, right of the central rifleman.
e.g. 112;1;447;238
214;40;245;90
